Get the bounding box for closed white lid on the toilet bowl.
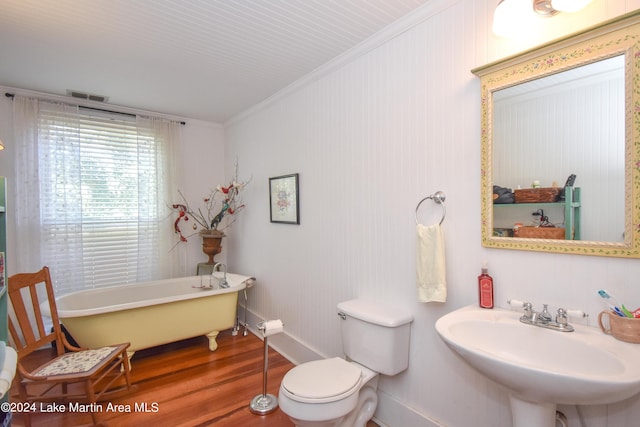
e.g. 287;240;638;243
282;357;362;399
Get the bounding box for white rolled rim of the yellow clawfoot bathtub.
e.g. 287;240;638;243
45;273;255;320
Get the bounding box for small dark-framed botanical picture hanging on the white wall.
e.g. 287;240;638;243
269;173;300;225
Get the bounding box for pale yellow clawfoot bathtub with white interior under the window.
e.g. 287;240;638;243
47;273;254;358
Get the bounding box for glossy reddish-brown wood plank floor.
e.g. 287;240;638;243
11;331;376;427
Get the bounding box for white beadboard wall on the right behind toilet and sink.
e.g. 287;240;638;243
225;0;640;427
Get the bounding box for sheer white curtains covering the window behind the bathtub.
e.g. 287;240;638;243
13;95;180;294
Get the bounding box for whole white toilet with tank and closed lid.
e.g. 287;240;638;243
278;299;413;427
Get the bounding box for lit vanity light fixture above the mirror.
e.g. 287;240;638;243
493;0;591;37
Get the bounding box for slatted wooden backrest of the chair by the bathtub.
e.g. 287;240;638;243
7;267;64;359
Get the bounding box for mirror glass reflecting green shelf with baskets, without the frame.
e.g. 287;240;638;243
492;55;625;242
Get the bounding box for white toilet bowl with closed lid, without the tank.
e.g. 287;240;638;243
278;357;378;427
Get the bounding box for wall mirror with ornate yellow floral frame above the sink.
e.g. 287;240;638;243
472;11;640;258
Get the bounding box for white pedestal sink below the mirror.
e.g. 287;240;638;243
436;306;640;427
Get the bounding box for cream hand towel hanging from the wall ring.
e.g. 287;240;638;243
416;224;447;302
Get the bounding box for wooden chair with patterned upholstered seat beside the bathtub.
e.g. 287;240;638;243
7;267;131;427
